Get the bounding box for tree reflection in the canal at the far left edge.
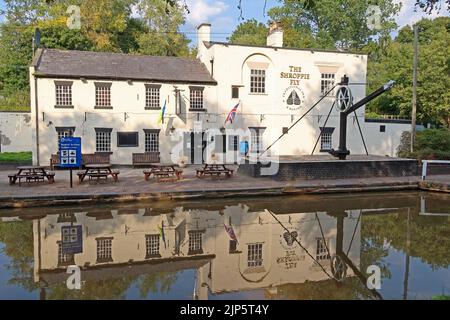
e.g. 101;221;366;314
0;221;39;292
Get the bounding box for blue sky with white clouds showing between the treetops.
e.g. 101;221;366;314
0;0;450;43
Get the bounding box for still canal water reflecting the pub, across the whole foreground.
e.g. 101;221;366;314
0;192;450;300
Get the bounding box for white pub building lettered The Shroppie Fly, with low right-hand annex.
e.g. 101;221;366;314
30;24;409;165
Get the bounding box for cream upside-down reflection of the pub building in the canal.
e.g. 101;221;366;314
34;205;360;298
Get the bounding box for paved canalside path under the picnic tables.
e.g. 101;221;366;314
0;167;450;207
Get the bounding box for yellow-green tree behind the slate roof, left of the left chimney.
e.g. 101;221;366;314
137;0;190;56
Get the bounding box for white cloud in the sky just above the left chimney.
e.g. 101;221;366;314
186;0;228;26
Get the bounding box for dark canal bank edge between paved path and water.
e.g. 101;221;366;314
0;181;450;209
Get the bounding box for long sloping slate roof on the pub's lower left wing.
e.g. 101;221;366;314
33;49;216;84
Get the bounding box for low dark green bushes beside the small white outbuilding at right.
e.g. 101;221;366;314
397;129;450;160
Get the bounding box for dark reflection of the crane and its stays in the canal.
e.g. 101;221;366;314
267;210;383;300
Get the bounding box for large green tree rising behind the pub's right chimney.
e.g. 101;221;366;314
269;0;400;50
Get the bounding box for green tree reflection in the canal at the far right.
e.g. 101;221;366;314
361;213;450;270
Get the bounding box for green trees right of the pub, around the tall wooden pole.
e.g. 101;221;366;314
365;17;450;128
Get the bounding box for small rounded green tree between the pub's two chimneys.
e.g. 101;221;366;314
228;19;268;46
